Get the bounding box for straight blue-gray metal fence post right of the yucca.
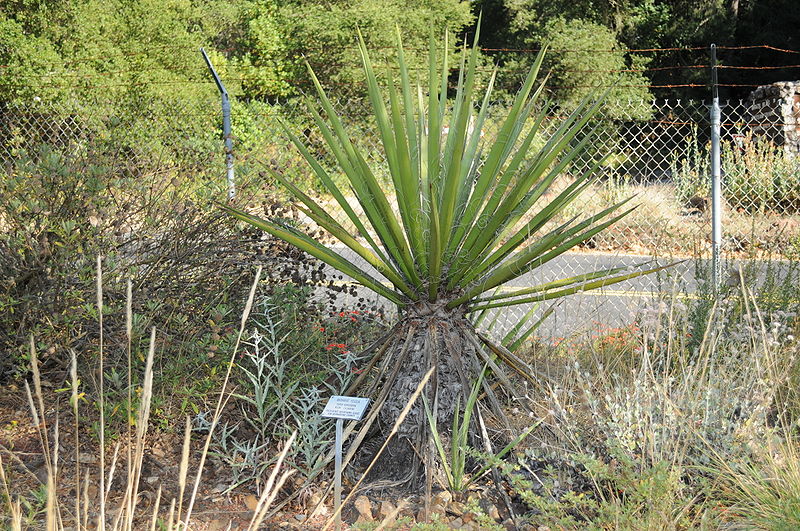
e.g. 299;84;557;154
711;44;722;294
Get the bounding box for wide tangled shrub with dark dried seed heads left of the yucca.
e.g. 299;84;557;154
0;134;336;428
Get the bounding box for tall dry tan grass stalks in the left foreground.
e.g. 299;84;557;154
0;259;295;531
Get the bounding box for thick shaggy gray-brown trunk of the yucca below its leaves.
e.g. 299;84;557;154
359;303;488;491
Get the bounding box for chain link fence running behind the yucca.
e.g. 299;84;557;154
0;95;800;335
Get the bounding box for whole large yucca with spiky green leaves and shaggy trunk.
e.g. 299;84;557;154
222;25;668;485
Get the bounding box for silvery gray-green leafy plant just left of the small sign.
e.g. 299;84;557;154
195;297;368;491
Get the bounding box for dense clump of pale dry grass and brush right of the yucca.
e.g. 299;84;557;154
506;276;800;530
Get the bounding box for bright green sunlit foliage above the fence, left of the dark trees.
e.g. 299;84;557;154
0;0;473;105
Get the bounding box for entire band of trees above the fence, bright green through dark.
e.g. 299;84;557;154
0;0;800;108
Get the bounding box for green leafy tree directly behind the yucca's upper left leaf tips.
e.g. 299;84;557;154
238;0;472;97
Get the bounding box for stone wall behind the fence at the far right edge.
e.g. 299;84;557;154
748;81;800;157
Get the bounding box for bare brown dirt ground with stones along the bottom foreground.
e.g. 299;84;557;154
0;385;528;531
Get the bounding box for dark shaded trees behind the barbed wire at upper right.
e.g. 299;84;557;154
474;0;800;101
